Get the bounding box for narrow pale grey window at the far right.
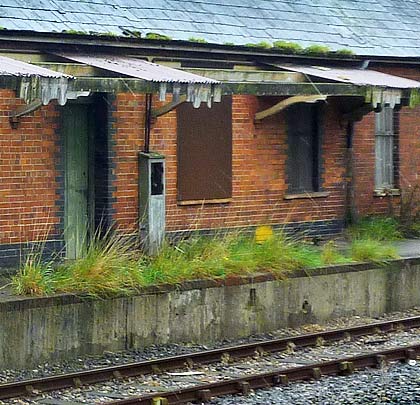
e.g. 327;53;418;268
375;107;395;189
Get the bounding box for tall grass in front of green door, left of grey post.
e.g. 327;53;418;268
12;233;141;296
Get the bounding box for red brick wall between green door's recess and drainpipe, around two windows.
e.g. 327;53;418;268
112;93;345;232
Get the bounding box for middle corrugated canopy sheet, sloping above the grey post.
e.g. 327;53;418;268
60;53;220;84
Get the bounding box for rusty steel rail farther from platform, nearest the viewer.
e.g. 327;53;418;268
103;345;420;405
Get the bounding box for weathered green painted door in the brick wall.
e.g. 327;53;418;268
63;104;89;259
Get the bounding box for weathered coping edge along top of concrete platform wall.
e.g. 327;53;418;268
0;256;420;312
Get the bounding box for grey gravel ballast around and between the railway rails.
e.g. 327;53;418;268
0;308;420;404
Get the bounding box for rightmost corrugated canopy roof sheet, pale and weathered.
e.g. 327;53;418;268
276;64;420;89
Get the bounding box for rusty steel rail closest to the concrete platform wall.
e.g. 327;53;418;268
0;316;420;400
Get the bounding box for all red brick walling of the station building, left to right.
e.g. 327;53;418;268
0;65;420;249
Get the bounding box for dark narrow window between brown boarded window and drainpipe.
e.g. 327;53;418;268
286;103;320;193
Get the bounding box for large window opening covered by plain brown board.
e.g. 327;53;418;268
177;97;232;201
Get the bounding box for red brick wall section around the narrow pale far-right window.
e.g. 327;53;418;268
354;67;420;216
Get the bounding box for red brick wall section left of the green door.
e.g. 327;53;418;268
0;89;63;265
